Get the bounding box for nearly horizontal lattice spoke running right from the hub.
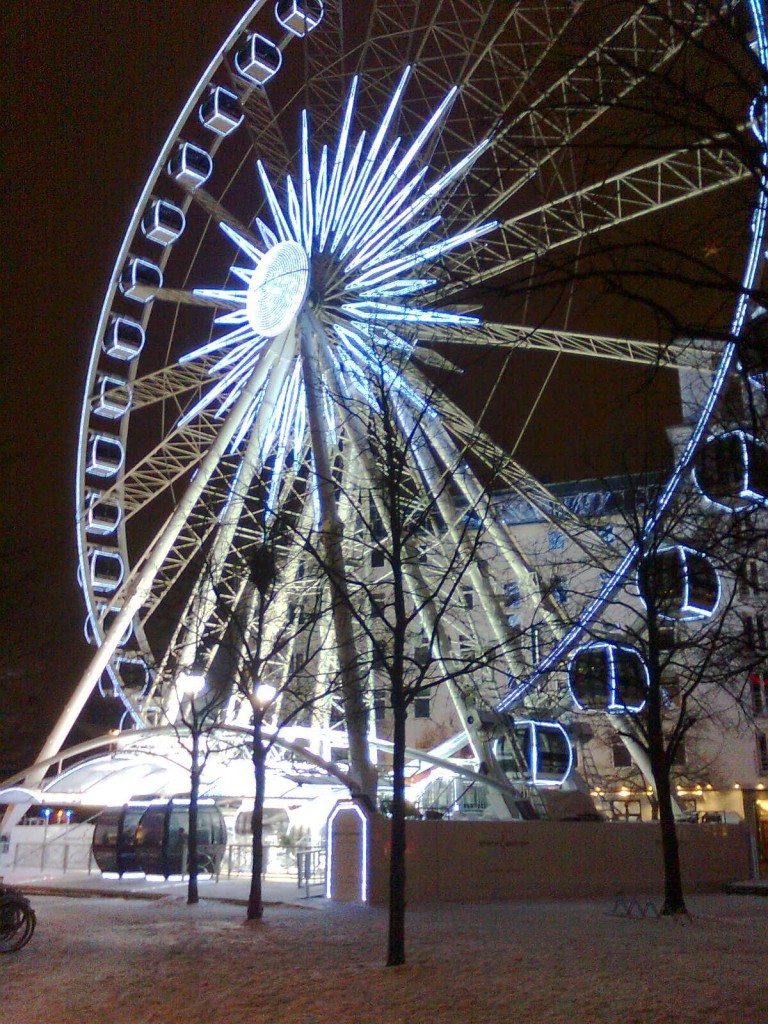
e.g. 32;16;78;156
415;324;722;370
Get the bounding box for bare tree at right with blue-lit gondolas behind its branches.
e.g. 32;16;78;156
528;460;768;914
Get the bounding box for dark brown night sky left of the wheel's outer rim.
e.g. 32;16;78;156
0;0;243;761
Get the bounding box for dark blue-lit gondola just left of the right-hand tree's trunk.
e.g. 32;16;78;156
568;641;648;715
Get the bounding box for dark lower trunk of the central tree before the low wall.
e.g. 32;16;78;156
387;693;407;967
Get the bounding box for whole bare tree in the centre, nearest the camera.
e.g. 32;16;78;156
305;342;516;966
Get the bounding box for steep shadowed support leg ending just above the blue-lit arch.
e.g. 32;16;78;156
299;312;377;806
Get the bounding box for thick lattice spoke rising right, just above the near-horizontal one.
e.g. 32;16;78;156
435;136;753;296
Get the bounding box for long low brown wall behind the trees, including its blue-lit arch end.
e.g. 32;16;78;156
331;814;750;904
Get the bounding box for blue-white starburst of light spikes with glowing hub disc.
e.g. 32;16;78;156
181;68;497;499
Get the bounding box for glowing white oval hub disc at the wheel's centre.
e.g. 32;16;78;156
246;242;309;338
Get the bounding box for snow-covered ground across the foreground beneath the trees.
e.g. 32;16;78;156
0;895;768;1024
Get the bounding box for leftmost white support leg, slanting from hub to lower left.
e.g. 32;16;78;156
28;354;282;781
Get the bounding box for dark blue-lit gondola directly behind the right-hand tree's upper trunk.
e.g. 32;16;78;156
638;544;720;622
